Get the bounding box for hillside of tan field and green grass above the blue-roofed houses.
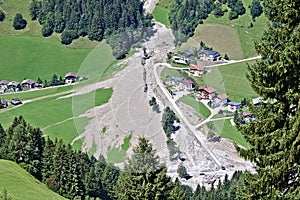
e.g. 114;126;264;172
177;0;268;59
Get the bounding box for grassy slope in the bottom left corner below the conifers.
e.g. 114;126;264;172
0;160;64;200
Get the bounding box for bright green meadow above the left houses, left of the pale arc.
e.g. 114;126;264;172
0;36;94;82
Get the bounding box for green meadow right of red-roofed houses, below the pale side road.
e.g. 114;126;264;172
203;61;258;101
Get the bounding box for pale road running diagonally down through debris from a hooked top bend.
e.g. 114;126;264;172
154;63;222;166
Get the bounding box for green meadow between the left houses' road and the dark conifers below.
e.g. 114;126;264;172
0;88;112;148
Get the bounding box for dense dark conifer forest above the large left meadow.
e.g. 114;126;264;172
29;0;151;58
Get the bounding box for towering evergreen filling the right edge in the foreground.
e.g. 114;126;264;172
239;0;300;199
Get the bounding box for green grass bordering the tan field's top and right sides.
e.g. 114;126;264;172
203;0;268;58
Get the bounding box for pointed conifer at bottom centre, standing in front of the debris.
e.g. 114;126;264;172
116;137;173;199
